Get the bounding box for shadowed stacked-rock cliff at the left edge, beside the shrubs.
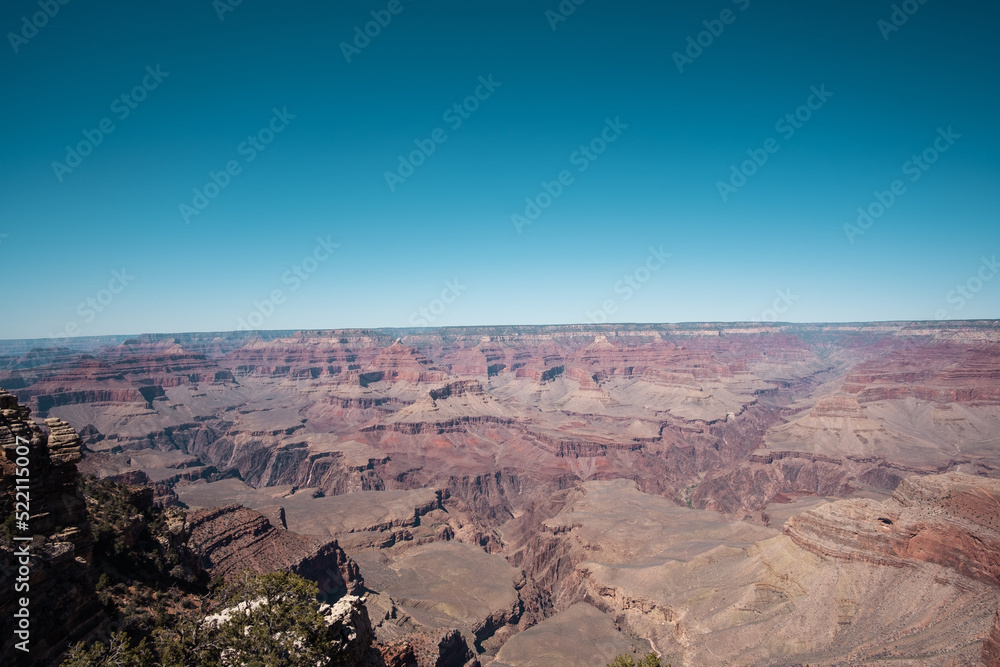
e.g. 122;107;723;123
0;389;106;665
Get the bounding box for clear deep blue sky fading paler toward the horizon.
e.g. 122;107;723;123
0;0;1000;338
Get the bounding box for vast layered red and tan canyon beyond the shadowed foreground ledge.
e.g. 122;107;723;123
0;321;1000;667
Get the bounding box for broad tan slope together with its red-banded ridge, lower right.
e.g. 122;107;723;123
511;474;1000;665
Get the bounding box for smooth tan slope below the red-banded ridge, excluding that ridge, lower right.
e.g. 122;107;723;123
508;478;998;665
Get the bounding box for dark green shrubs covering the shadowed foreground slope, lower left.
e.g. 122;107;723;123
62;477;356;667
